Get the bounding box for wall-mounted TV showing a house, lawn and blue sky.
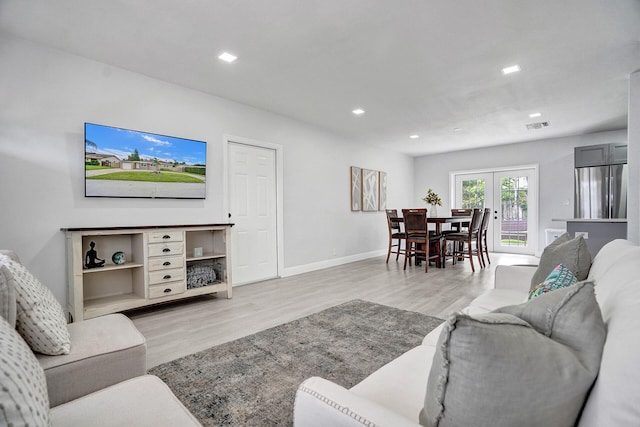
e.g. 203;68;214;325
84;123;207;199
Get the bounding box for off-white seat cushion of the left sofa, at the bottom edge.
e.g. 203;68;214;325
51;375;201;427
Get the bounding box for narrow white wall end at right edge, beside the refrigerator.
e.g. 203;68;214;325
627;70;640;245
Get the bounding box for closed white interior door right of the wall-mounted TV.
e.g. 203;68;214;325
228;143;278;285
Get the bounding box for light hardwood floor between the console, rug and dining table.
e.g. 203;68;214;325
127;253;537;368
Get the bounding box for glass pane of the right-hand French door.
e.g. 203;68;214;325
500;176;529;247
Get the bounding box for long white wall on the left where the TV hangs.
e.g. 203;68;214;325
0;35;413;302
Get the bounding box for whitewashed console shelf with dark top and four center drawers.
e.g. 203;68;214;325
62;224;232;321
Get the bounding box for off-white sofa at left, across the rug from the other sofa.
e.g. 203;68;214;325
0;250;200;427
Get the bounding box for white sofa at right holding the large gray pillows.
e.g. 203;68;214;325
294;240;640;427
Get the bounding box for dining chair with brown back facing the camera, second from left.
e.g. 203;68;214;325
402;209;441;273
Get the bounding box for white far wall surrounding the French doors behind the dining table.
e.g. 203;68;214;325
413;130;638;252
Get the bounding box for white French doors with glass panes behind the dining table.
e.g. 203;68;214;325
452;167;538;255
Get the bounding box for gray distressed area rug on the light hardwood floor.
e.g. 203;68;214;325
149;300;442;426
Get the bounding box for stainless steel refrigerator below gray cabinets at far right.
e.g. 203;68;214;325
574;164;628;218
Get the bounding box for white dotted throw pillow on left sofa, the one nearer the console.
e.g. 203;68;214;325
0;255;71;355
